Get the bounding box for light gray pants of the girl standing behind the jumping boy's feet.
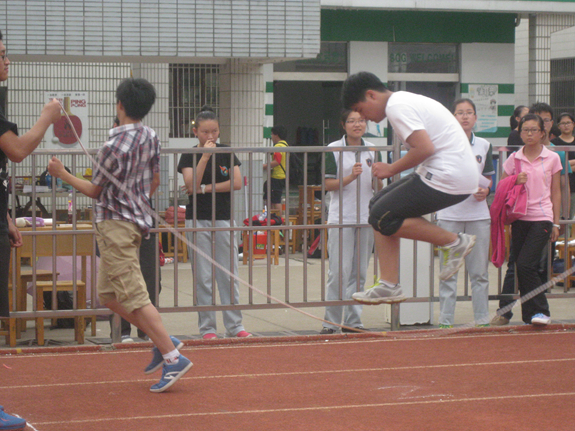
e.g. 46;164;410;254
437;220;491;325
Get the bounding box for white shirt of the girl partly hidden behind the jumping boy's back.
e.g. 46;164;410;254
437;135;495;221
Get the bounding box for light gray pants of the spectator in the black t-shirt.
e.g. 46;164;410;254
186;220;244;337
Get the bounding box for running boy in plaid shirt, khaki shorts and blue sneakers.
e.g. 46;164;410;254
48;78;192;392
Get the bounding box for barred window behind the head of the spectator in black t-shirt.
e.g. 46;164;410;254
169;64;220;138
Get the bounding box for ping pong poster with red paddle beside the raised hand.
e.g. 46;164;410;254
45;91;89;149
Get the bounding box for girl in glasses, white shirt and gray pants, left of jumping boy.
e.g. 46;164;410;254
320;109;381;334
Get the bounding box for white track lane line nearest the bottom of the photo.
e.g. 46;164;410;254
32;392;575;425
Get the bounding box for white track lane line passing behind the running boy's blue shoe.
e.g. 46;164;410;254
0;358;575;393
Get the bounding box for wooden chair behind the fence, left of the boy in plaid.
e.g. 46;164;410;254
17;225;96;346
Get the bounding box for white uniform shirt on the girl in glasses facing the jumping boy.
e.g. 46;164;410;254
325;136;380;224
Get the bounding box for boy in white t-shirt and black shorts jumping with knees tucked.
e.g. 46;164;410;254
342;72;479;304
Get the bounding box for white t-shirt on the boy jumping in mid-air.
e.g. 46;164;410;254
385;91;479;195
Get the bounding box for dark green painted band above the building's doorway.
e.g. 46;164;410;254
321;9;516;43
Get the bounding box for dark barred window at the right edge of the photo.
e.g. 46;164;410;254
551;58;575;115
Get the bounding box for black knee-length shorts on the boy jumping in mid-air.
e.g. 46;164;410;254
369;173;469;236
